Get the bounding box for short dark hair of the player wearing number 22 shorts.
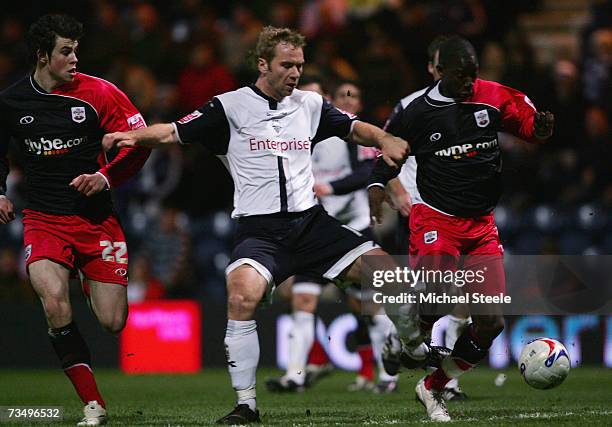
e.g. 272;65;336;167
27;14;83;62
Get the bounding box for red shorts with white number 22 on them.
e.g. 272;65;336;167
23;209;128;286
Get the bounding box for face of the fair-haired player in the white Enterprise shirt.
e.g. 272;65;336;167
260;43;304;100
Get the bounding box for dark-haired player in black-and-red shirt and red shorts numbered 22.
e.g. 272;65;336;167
0;15;150;425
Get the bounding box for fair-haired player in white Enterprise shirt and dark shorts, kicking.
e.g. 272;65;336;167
103;27;408;424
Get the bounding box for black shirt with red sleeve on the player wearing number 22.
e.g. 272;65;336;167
0;73;150;216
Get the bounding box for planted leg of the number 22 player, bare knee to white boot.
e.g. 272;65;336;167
28;260;106;425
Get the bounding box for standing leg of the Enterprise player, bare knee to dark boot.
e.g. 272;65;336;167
217;264;268;424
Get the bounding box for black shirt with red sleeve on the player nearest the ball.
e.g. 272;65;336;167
370;79;538;217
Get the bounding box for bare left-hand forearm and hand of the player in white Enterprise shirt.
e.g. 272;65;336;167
102;123;178;151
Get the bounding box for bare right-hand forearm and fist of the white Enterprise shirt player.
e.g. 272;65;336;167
350;122;410;168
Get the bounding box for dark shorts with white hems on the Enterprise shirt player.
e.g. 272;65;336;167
225;205;378;284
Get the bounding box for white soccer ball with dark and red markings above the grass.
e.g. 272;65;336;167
519;338;570;390
